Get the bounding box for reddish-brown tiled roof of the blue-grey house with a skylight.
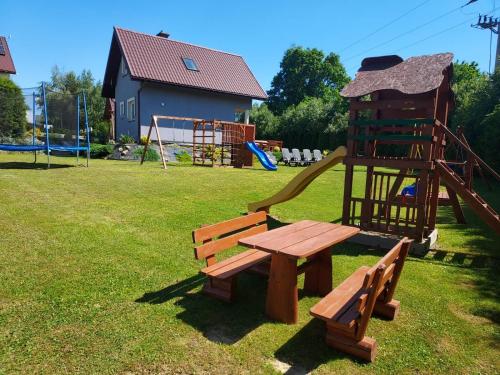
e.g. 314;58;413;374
104;28;267;99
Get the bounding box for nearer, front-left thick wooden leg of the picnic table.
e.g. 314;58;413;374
266;254;299;324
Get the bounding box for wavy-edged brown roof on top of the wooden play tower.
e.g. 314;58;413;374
341;53;453;98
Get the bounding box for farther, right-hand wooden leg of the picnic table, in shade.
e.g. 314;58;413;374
304;248;333;296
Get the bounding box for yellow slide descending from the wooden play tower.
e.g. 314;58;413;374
248;146;347;212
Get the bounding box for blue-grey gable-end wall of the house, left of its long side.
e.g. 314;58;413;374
115;59;141;139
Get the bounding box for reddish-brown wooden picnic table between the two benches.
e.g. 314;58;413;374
239;220;359;324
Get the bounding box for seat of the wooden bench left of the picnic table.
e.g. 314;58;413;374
201;249;271;279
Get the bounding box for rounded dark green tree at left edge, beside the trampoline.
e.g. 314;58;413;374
0;76;28;138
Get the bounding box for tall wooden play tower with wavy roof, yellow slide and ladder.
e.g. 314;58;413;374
248;53;500;245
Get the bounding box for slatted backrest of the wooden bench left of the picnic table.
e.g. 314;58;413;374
193;211;267;266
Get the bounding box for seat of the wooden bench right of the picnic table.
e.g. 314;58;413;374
311;266;370;321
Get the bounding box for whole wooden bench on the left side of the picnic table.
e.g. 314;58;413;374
193;211;271;302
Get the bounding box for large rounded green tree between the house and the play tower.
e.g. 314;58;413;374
268;47;349;115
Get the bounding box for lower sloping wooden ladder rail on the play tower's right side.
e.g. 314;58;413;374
436;160;500;233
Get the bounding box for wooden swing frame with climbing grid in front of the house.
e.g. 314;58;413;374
141;115;255;169
